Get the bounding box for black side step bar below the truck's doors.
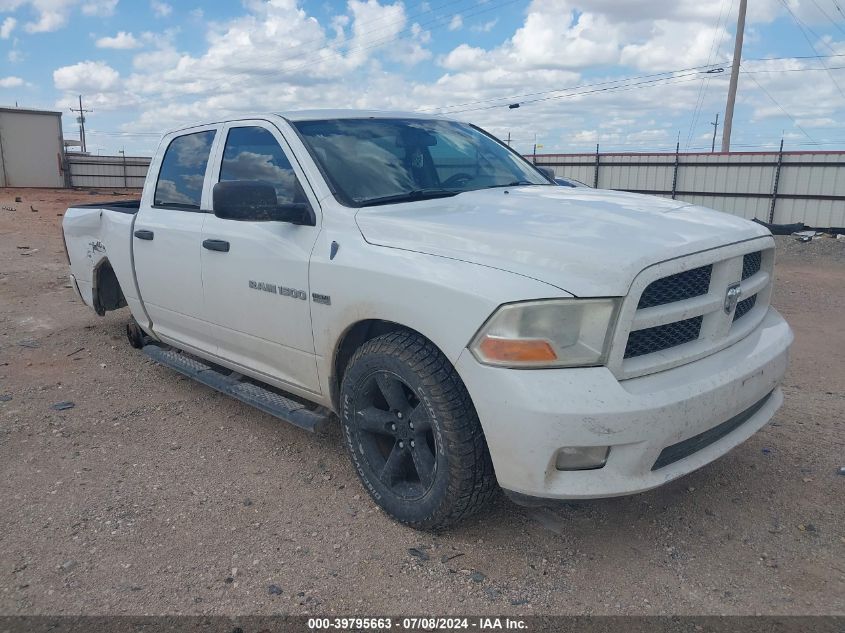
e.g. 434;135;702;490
141;345;330;433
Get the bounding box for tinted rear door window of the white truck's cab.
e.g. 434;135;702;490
153;130;215;210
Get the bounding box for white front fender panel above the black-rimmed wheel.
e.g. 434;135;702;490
311;232;570;408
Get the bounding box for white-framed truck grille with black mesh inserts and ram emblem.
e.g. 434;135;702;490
610;241;774;378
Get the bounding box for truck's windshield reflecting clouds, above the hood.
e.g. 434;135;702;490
293;119;550;207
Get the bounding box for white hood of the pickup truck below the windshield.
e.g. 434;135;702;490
356;186;770;297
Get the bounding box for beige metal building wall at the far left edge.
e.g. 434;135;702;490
0;108;65;187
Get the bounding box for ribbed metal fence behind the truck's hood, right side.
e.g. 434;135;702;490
536;146;845;228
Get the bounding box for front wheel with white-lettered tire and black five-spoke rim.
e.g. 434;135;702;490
340;331;498;530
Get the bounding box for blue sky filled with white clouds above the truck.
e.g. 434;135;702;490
0;0;845;155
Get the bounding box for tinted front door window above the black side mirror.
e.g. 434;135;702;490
220;126;306;204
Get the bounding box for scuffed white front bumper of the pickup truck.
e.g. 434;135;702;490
456;308;793;499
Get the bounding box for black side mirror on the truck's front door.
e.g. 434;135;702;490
212;180;313;224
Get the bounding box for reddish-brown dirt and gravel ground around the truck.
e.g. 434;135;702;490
0;189;845;615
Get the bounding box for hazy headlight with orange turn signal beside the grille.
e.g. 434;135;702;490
470;299;619;367
